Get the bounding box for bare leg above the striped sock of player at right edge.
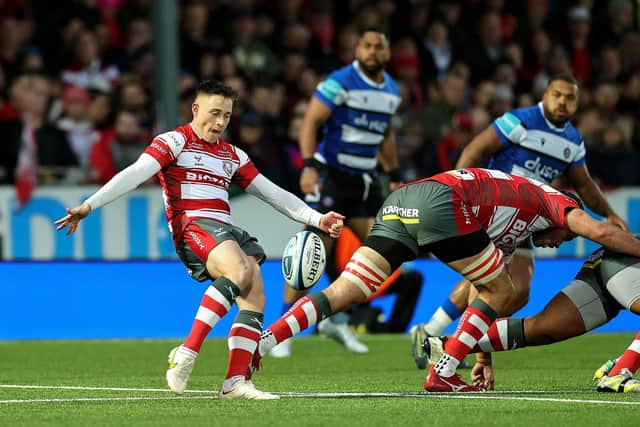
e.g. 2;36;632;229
524;285;588;345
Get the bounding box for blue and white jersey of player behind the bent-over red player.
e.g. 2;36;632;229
488;103;585;184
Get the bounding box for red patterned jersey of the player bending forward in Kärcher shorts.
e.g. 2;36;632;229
427;168;579;260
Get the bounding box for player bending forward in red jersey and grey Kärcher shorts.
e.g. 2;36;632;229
254;168;640;392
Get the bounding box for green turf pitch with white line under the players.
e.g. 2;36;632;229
0;334;640;427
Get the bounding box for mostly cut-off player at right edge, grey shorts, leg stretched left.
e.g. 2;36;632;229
423;234;640;393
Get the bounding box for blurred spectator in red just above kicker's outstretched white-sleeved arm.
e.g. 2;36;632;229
89;111;147;184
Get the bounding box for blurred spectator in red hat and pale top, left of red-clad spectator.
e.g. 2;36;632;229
57;86;98;168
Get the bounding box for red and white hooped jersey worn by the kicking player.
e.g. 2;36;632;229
144;124;259;240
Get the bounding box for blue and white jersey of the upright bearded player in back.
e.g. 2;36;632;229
314;61;400;174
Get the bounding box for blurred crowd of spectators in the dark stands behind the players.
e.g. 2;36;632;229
0;0;640;197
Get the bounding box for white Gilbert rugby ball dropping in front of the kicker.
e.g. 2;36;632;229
282;230;327;291
